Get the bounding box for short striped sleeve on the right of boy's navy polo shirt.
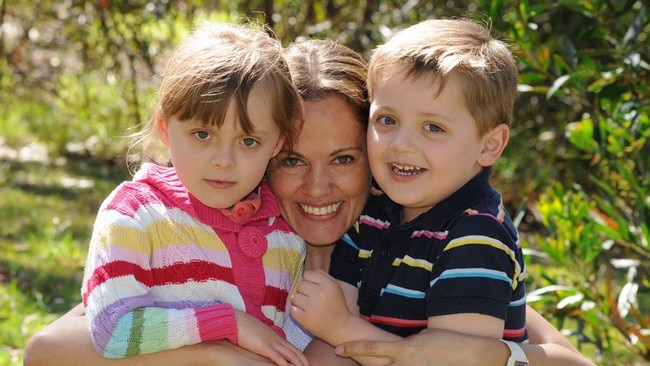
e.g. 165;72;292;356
426;215;523;320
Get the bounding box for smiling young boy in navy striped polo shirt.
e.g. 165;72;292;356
292;19;527;366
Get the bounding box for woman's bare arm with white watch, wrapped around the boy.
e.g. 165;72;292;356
336;307;594;366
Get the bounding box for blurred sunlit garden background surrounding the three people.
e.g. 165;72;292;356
0;0;650;365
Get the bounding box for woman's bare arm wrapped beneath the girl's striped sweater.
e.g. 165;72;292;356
24;305;274;366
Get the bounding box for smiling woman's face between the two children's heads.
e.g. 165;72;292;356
268;96;370;245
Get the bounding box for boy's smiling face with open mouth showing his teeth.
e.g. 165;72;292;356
368;69;484;222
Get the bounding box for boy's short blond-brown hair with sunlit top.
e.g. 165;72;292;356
368;19;517;136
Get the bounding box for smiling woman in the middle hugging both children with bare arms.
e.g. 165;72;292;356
24;40;591;366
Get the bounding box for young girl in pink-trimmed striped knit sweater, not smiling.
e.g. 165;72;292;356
82;20;306;365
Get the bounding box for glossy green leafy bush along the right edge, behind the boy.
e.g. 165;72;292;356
529;2;650;364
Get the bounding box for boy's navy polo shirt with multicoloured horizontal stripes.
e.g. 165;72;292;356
330;170;528;342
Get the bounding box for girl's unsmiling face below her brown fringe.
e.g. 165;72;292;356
158;85;282;208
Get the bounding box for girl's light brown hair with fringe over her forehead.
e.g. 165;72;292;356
128;23;303;164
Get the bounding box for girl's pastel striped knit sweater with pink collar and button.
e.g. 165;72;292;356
81;164;305;358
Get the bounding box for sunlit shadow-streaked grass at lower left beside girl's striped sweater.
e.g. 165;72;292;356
0;150;128;365
